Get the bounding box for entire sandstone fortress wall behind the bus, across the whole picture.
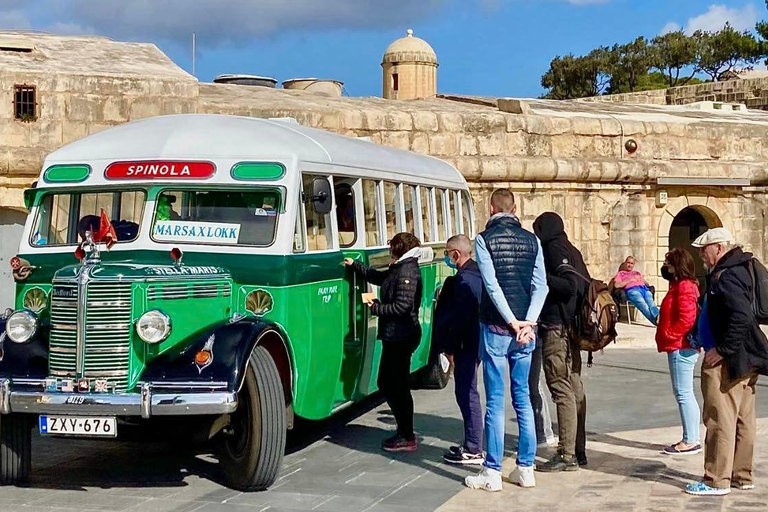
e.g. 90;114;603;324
0;30;768;308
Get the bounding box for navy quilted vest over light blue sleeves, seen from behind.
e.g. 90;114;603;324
480;214;539;326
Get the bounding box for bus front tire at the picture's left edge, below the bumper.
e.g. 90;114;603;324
0;414;33;485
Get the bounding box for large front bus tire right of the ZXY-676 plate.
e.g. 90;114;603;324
218;346;287;491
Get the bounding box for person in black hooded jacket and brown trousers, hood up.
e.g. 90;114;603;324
533;212;589;472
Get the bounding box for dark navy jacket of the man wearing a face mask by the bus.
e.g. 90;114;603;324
432;260;483;356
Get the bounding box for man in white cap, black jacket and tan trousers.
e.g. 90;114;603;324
685;228;768;496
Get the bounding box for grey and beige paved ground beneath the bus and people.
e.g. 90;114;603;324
0;326;768;512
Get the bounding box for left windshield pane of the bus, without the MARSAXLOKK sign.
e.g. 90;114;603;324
30;190;146;246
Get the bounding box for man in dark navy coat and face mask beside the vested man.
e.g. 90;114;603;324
432;235;485;464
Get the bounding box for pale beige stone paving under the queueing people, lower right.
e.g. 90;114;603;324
438;418;768;512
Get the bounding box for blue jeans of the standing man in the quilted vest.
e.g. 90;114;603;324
480;325;536;471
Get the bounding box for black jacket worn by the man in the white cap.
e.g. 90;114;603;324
707;247;768;380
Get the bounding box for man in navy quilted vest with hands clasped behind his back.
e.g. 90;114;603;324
464;189;548;491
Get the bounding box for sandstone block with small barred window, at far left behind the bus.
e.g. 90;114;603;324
0;32;198;307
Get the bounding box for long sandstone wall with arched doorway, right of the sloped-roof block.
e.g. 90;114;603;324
200;85;768;282
